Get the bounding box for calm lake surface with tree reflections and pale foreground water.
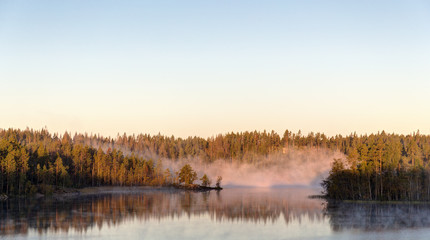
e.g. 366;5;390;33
0;188;430;240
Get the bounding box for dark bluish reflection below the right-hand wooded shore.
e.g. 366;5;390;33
325;202;430;232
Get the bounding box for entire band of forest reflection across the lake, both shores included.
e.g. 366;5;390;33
5;188;430;238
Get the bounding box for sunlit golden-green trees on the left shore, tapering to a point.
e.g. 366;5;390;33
0;129;215;195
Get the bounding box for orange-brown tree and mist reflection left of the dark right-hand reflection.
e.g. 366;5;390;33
0;188;323;236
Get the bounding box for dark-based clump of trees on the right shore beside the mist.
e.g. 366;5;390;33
322;132;430;201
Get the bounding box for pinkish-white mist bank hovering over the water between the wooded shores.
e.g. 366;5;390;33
162;148;345;187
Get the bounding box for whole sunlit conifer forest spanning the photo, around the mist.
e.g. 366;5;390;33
0;129;430;200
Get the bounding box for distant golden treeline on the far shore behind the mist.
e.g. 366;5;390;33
42;130;348;163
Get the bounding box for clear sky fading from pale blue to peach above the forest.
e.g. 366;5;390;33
0;0;430;137
